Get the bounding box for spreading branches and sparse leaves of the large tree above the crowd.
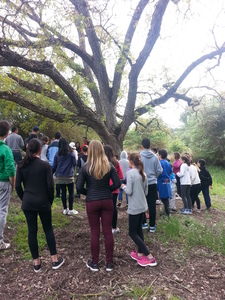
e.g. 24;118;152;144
0;0;225;153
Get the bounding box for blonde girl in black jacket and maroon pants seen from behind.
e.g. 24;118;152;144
76;140;120;271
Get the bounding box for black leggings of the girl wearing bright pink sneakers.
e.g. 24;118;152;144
129;213;150;256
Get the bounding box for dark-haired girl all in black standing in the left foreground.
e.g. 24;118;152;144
16;138;64;273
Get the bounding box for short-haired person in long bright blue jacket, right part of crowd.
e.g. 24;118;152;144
157;149;173;216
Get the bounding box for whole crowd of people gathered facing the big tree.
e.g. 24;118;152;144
0;121;211;272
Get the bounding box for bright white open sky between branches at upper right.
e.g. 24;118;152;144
113;0;225;128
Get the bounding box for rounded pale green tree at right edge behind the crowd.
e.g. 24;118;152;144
179;95;225;166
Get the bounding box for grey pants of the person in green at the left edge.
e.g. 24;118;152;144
0;181;12;244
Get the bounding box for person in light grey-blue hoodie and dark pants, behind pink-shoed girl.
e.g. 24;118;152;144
140;138;163;233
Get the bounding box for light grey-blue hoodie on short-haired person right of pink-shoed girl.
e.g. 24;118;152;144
140;149;163;185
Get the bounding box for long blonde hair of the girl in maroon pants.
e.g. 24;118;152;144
87;140;111;180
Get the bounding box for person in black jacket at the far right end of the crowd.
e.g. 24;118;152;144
198;159;212;210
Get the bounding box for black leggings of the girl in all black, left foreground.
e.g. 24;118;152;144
23;210;57;259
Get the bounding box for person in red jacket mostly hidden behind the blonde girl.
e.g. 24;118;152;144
104;145;123;234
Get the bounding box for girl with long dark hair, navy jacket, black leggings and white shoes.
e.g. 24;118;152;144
53;138;78;215
